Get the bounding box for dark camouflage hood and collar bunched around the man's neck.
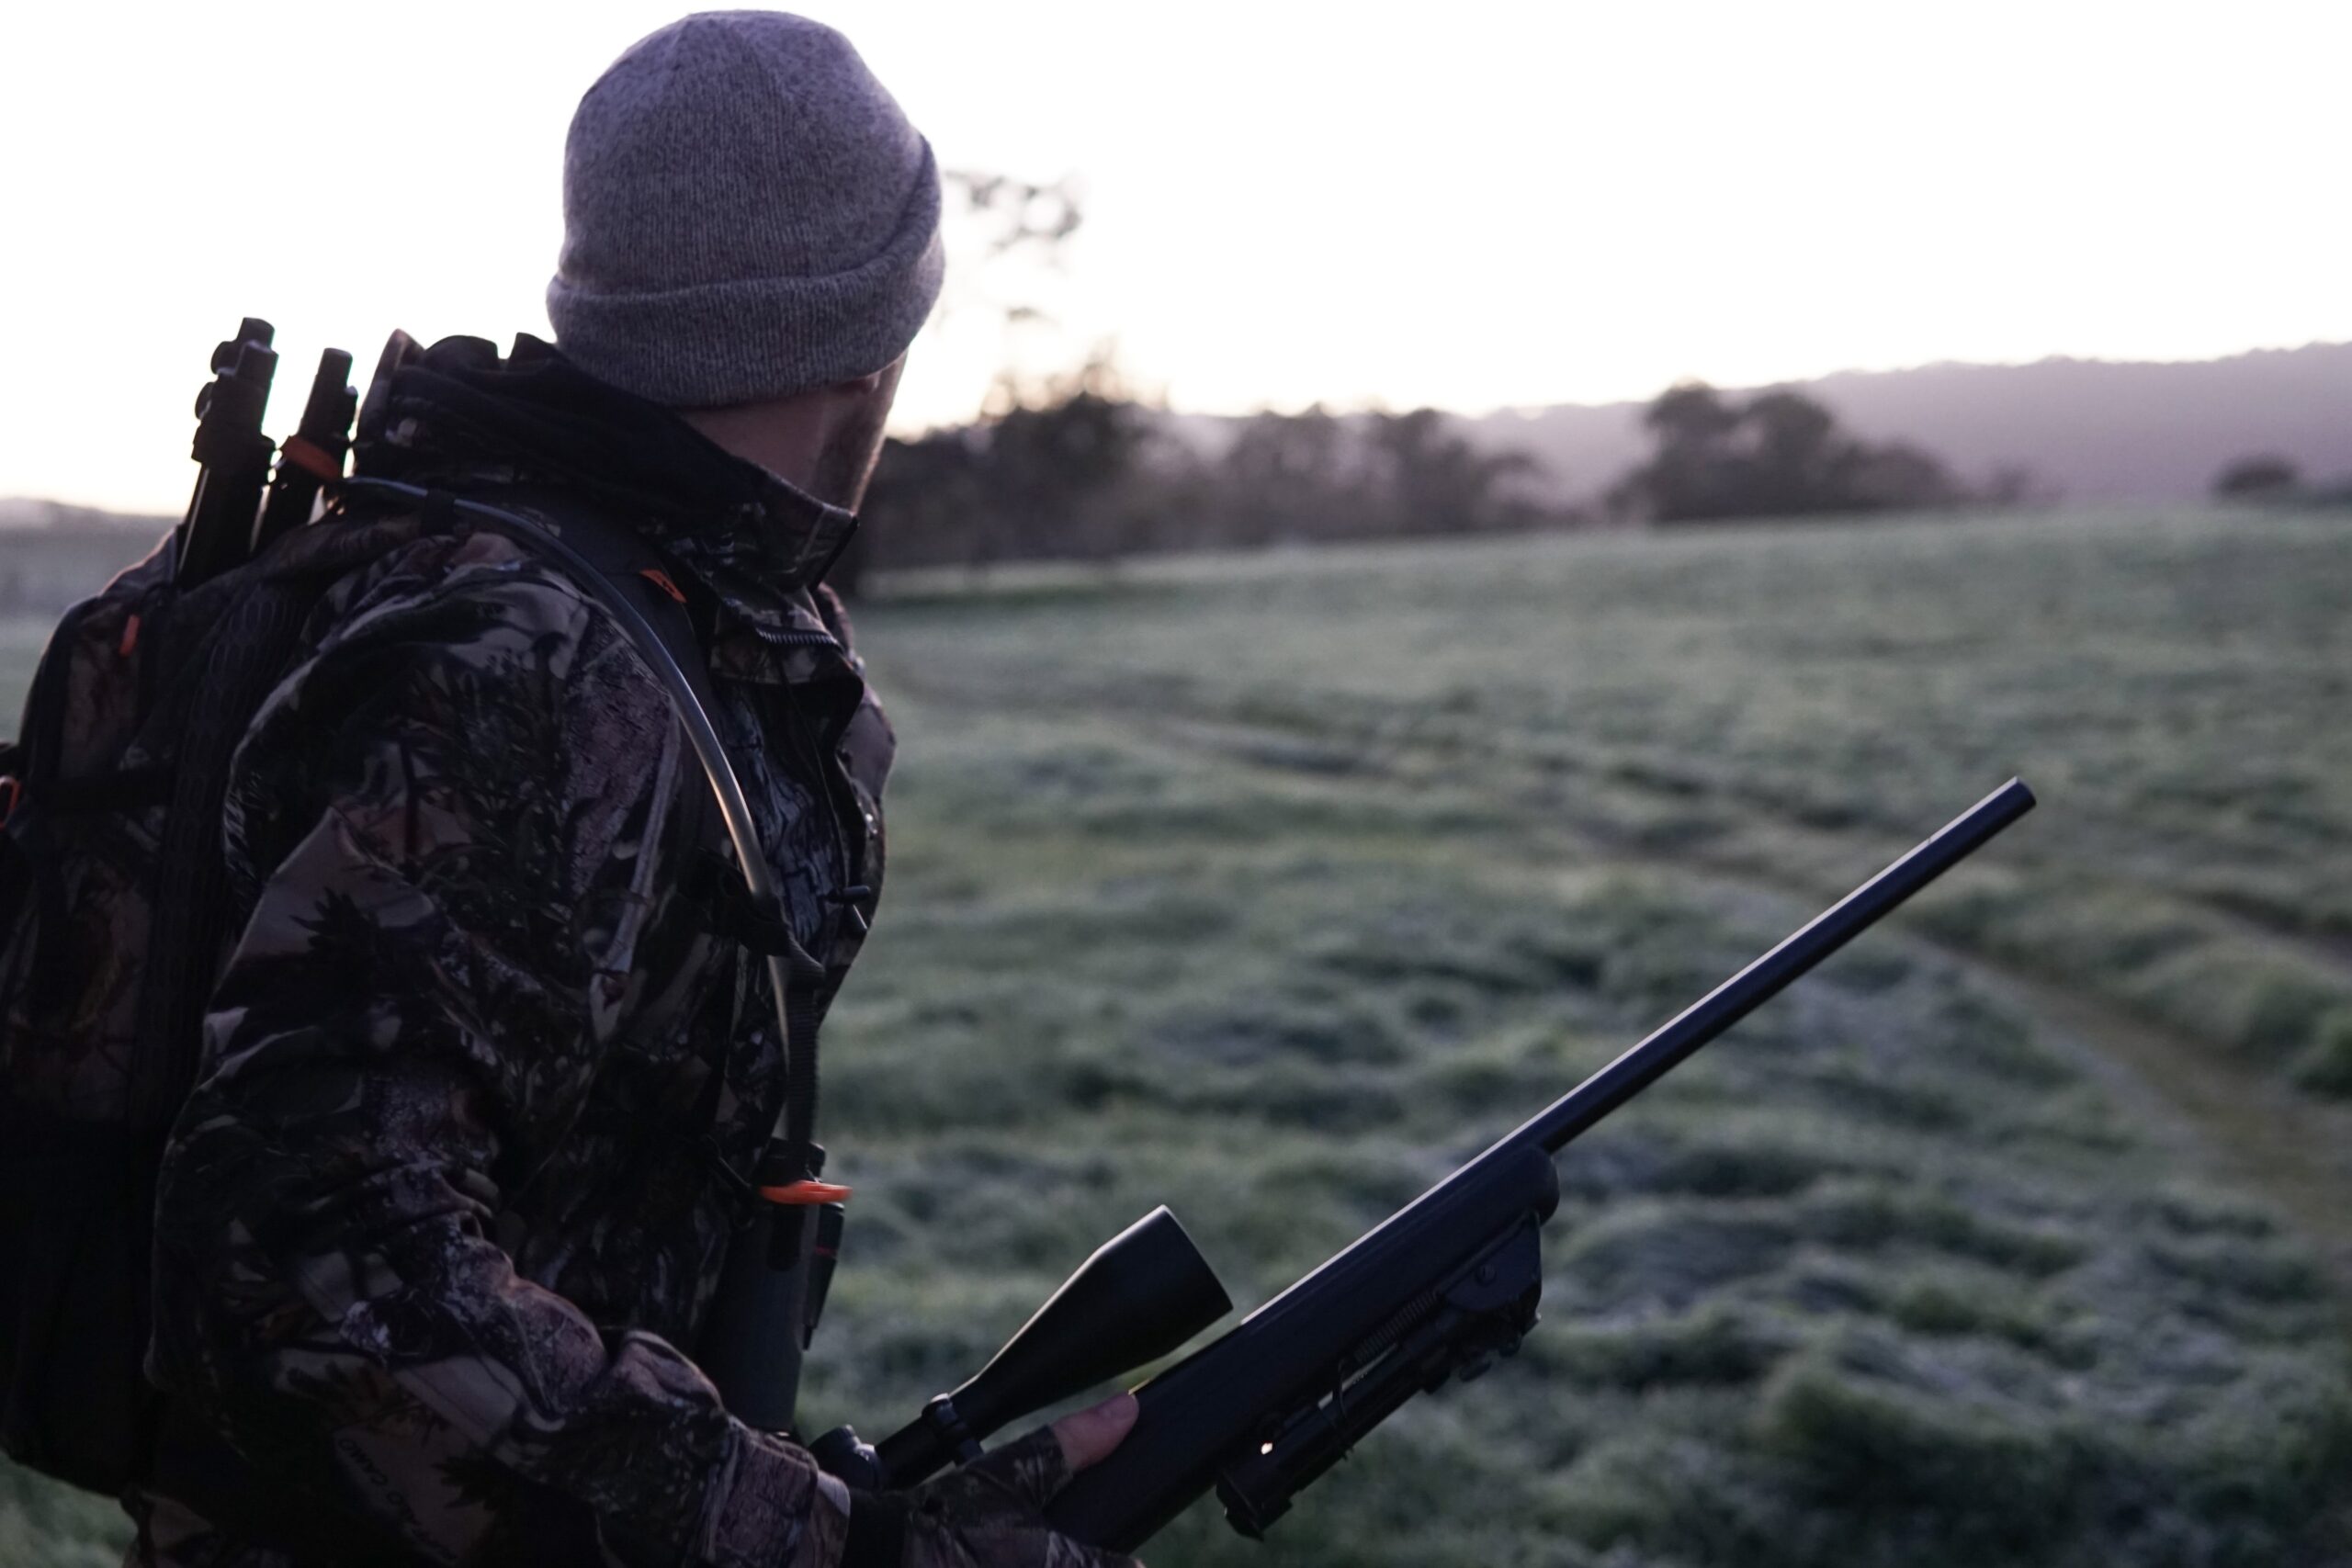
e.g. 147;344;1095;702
356;333;856;635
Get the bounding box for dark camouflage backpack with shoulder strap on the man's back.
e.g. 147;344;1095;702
0;460;820;1495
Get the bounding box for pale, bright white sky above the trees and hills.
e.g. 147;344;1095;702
0;0;2352;513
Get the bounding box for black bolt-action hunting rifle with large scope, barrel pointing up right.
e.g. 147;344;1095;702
814;778;2034;1551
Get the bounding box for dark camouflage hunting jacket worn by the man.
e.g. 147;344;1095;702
131;344;891;1568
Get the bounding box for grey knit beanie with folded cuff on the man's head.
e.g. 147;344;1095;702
548;12;944;409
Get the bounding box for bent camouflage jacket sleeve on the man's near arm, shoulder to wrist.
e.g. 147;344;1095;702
151;562;849;1568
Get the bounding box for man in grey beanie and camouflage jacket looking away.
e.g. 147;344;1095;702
131;12;1134;1568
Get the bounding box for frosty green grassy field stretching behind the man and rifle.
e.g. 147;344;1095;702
0;513;2352;1568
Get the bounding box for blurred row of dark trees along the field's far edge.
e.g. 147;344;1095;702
835;371;2037;585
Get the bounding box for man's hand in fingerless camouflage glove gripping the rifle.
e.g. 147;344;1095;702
842;1394;1138;1568
